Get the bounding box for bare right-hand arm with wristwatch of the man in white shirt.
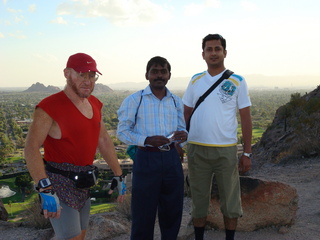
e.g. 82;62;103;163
239;107;252;173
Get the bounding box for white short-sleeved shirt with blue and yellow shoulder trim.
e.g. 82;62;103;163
182;71;251;147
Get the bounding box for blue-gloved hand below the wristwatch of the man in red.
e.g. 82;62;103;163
39;189;61;218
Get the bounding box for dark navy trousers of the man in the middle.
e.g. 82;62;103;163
131;148;184;240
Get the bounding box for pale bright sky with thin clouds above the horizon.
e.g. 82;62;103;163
0;0;320;88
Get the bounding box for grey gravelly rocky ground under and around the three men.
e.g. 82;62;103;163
0;158;320;240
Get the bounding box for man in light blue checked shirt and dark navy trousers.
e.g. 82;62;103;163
117;56;187;240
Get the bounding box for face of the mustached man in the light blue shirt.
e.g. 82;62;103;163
146;64;171;89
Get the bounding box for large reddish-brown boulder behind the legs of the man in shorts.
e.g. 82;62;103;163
208;177;298;232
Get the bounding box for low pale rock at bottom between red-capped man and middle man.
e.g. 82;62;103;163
86;212;131;240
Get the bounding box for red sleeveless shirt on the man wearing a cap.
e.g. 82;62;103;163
36;91;102;166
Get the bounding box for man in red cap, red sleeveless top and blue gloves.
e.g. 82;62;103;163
24;53;125;239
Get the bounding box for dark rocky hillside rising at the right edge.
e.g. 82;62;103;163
252;86;320;166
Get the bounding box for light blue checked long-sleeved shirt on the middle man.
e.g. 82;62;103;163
117;86;187;146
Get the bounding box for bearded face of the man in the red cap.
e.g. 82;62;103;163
67;69;96;98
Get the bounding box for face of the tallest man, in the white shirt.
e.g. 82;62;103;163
202;40;227;68
